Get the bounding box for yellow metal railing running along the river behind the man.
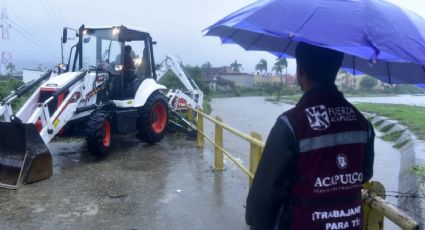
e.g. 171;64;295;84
188;108;419;230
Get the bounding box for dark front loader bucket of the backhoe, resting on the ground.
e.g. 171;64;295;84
0;122;53;189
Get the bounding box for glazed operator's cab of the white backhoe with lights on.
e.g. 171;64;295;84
63;25;156;100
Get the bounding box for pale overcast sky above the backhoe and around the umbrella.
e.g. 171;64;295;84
0;0;425;73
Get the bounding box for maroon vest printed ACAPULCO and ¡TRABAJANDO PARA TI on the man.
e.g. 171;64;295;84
282;88;368;230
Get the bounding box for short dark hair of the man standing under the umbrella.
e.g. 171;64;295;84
295;42;344;83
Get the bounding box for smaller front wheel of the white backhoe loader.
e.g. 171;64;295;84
86;110;112;157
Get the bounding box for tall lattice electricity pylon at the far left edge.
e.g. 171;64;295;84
0;7;12;74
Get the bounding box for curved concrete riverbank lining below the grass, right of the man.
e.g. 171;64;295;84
364;114;425;229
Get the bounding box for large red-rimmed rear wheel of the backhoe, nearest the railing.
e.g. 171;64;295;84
137;91;169;144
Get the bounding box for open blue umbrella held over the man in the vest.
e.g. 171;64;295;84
206;0;425;84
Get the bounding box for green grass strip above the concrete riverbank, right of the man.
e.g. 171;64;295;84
355;103;425;140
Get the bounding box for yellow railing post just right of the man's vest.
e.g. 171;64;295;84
363;181;385;230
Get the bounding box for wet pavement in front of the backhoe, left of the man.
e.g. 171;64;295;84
0;135;248;229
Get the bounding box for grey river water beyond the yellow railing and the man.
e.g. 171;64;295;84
204;96;400;229
